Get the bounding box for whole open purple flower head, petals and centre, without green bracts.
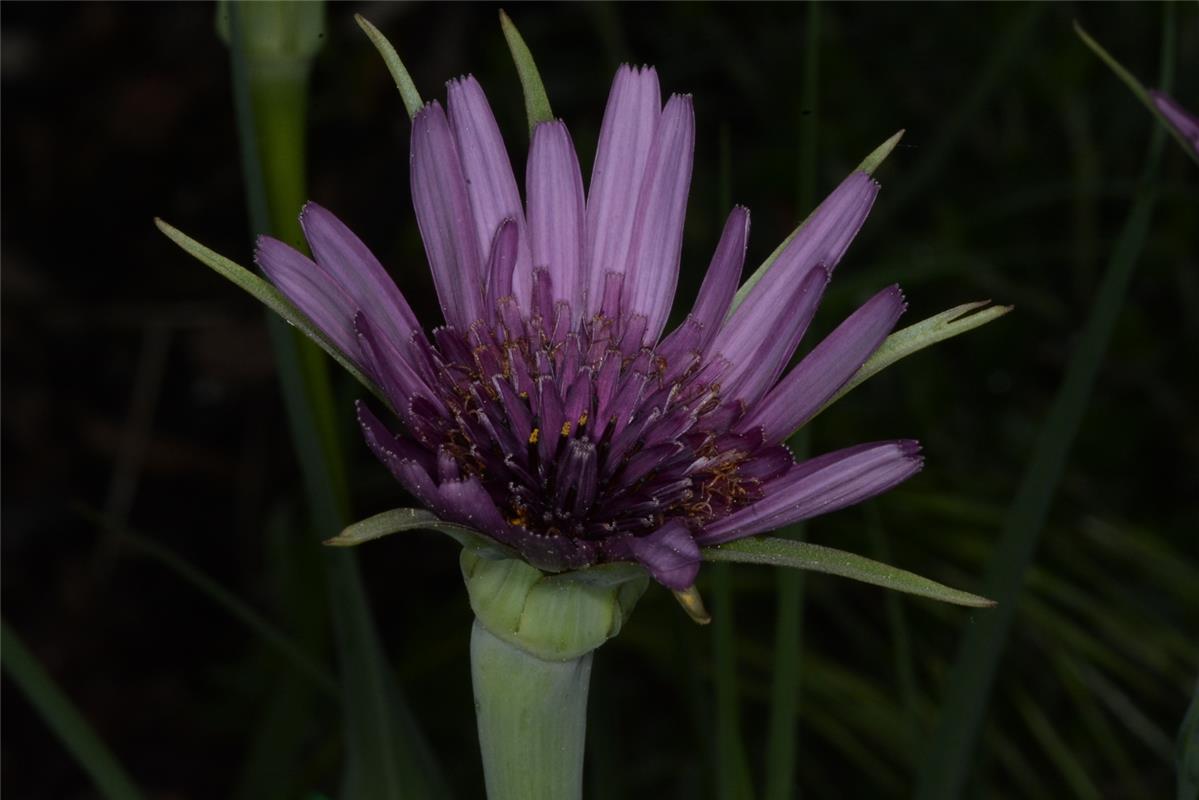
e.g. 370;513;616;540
255;66;921;590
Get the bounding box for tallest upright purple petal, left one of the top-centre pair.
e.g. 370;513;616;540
586;65;662;315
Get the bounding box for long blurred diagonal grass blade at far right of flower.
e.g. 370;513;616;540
916;5;1174;800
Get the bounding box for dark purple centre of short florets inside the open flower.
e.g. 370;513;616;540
386;270;793;540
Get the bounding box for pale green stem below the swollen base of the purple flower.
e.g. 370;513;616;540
470;620;595;800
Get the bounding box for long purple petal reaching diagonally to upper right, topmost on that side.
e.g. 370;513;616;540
712;172;879;362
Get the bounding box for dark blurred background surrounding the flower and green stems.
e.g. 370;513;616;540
2;2;1199;798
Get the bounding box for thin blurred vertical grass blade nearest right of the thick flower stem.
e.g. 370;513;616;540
709;564;753;800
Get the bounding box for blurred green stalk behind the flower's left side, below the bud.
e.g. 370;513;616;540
225;4;448;800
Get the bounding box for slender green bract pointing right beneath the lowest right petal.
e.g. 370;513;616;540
704;536;995;608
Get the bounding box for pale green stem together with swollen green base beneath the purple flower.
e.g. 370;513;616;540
459;554;649;800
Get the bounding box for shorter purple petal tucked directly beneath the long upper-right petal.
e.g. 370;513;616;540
705;267;829;404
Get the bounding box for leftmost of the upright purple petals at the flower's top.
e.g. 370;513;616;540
411;102;486;331
